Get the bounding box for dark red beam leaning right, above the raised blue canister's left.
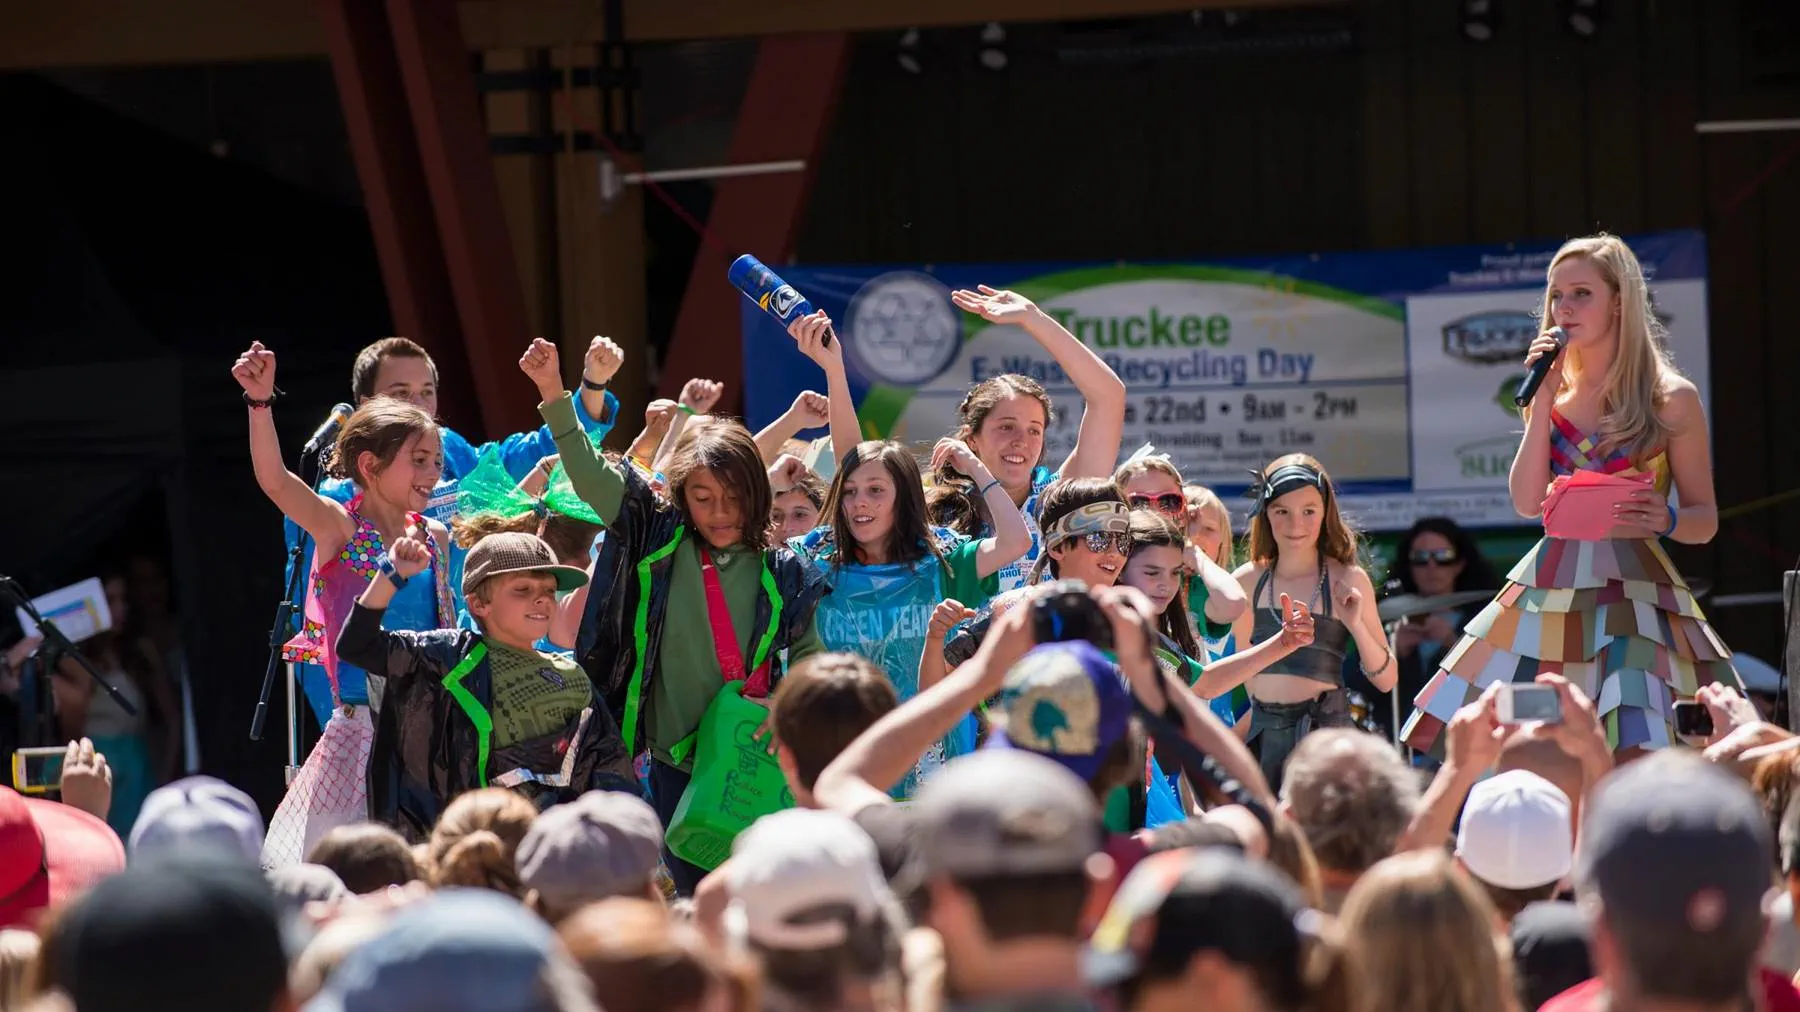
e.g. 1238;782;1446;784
659;32;851;411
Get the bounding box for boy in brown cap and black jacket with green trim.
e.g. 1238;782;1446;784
338;533;639;839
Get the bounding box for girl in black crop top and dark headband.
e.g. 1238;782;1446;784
1231;454;1395;789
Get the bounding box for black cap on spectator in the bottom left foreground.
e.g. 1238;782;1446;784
56;855;288;1012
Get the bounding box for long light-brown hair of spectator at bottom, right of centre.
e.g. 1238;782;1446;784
1337;850;1517;1012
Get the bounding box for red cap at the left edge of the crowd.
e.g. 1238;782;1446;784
0;787;124;927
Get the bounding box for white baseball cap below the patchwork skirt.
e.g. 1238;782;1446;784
1456;769;1575;890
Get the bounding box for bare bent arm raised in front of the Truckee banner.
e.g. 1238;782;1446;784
950;285;1125;477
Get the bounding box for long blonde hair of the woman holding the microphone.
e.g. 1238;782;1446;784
1539;232;1681;463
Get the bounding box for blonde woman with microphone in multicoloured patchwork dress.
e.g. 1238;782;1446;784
1404;234;1741;758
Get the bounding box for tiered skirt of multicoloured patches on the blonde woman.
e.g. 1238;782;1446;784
1402;538;1742;751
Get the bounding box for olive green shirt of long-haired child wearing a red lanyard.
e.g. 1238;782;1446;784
644;533;824;771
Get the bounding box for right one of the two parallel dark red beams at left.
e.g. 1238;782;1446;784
390;0;536;434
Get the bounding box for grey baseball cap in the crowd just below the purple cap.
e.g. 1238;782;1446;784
913;749;1100;879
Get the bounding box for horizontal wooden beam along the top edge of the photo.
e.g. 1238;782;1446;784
0;0;1348;70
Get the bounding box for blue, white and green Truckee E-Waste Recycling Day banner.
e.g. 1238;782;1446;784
743;230;1706;531
